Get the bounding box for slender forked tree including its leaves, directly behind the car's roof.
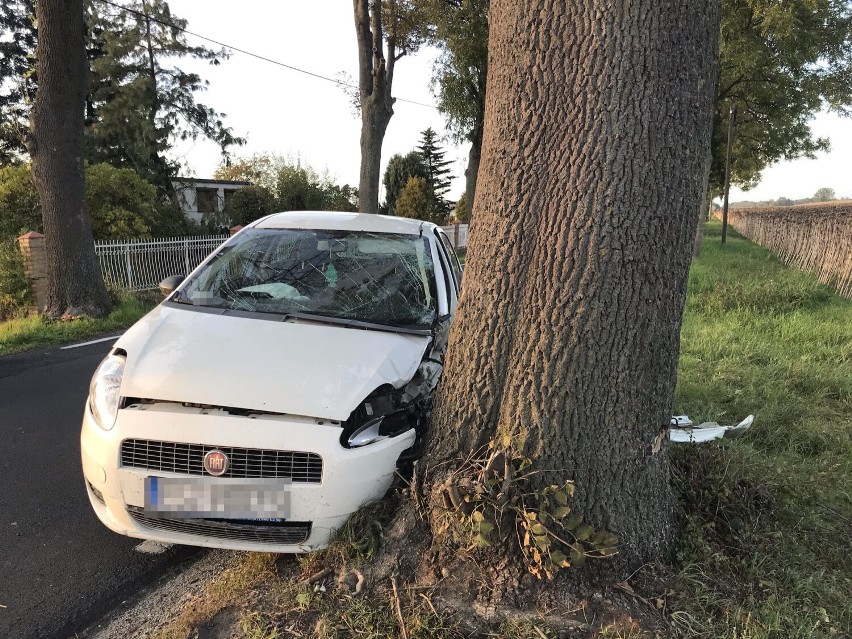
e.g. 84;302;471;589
353;0;425;213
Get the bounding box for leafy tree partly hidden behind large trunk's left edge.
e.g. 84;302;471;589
426;0;489;215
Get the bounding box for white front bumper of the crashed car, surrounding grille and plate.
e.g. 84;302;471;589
80;402;415;552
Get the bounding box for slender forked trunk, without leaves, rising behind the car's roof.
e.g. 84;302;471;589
354;0;397;213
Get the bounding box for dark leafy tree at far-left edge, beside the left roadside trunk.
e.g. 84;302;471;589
0;0;36;164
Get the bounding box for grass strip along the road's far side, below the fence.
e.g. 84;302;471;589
0;294;155;355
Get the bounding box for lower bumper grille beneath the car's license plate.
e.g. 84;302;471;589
127;506;312;544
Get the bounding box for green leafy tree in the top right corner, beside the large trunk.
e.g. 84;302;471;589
710;0;852;194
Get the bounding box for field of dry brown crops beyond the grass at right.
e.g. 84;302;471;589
728;201;852;299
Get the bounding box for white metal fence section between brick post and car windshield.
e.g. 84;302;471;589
95;235;228;291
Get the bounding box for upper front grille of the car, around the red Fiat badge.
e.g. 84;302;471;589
121;439;322;484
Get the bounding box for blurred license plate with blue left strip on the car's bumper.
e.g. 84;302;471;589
145;477;290;521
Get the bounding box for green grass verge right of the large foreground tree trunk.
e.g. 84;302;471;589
674;223;852;639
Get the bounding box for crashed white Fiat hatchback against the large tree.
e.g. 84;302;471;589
81;212;461;552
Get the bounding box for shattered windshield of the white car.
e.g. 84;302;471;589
172;229;437;327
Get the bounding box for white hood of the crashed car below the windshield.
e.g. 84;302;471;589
116;305;431;421
